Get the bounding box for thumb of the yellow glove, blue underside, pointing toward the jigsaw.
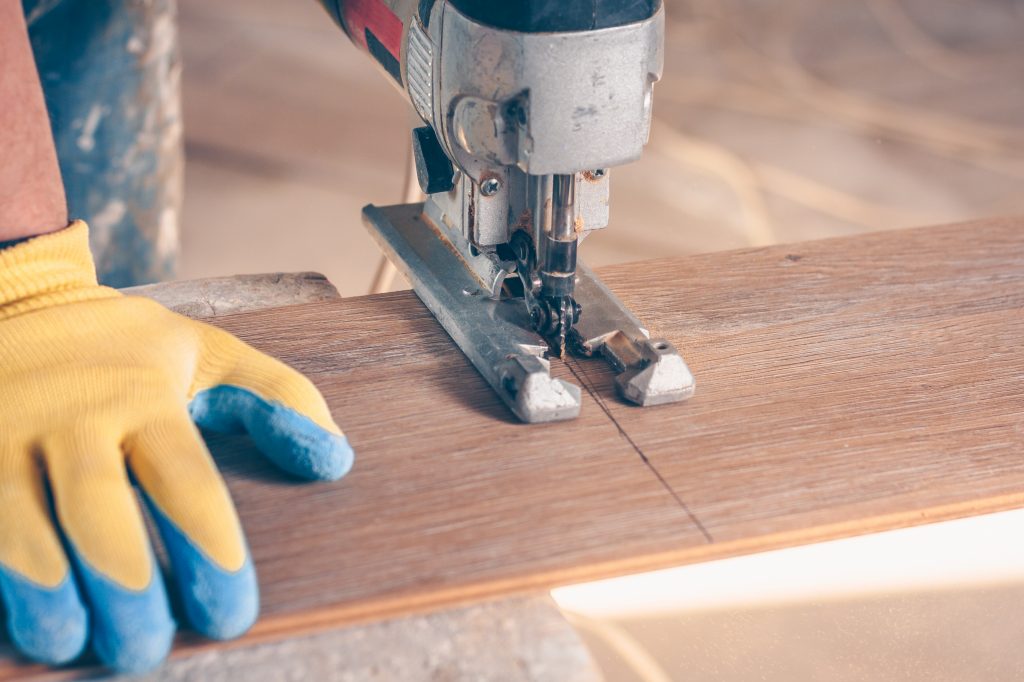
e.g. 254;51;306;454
189;328;353;480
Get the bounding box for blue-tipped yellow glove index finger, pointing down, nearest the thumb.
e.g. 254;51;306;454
126;411;259;639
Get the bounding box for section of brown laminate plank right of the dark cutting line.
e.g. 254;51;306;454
590;220;1024;558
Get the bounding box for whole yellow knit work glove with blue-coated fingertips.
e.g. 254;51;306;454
0;222;352;672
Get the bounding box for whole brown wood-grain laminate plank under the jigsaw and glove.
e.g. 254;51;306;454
0;219;1024;679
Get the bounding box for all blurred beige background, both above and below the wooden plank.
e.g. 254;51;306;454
179;0;1024;682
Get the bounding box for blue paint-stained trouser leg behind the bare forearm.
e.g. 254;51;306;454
23;0;183;287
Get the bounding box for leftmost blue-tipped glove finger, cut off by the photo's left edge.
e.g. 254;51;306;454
0;452;89;666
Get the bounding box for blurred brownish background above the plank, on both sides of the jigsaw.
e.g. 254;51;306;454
179;0;1024;296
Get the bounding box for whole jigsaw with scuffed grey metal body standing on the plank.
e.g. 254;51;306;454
322;0;694;422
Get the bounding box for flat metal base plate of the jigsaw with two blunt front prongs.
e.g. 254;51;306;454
362;204;695;423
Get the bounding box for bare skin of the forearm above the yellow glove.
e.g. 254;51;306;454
0;0;68;242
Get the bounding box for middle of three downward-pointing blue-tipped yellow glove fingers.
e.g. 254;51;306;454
44;434;175;673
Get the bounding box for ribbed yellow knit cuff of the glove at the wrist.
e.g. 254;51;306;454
0;220;120;319
